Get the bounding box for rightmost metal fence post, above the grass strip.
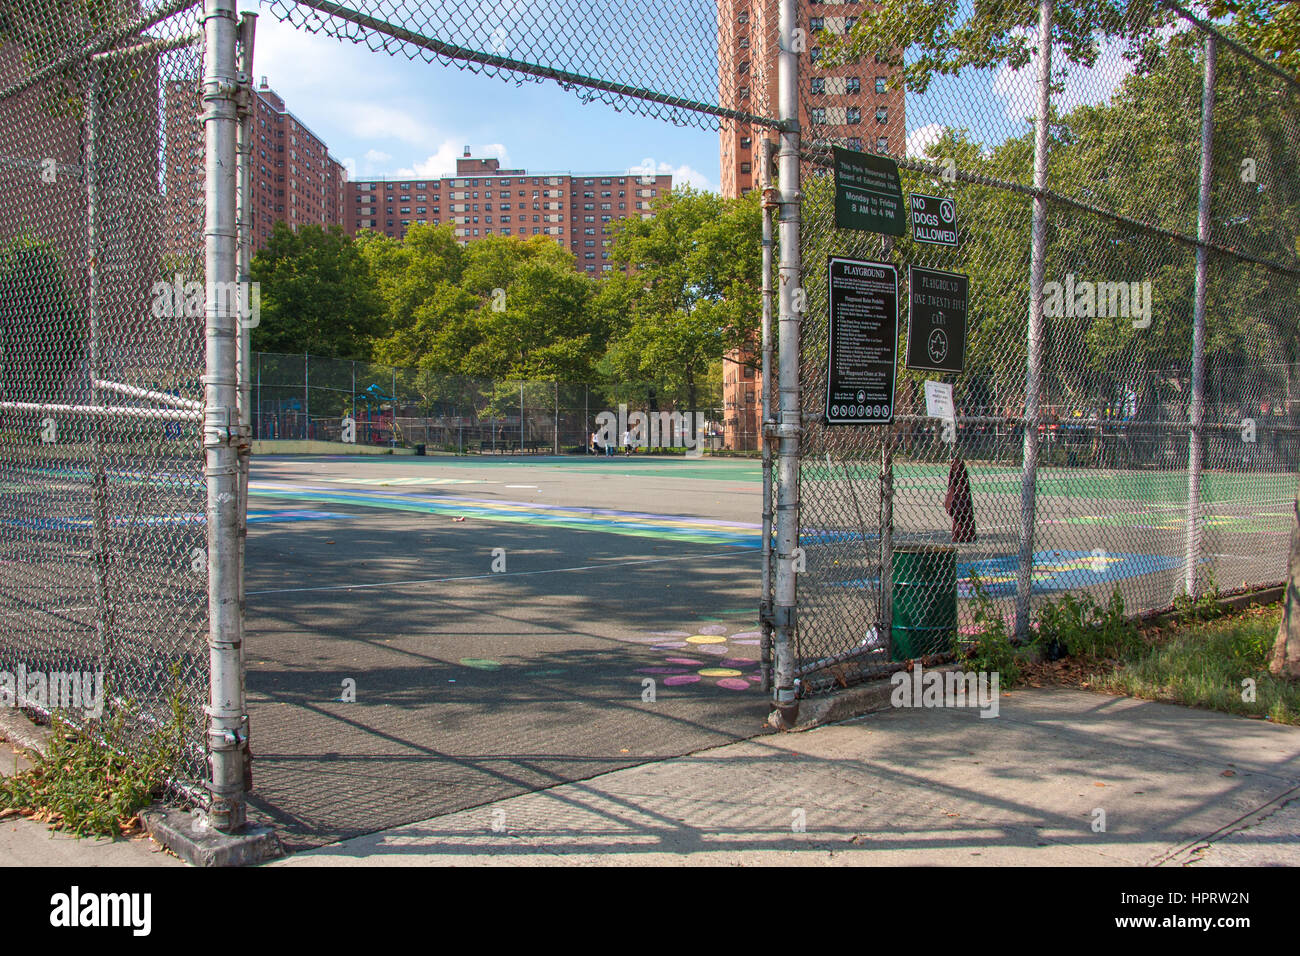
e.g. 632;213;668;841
1183;33;1218;597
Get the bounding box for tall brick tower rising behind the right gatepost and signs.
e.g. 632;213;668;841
718;0;906;447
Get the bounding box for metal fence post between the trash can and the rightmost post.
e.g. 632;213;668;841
1015;0;1053;637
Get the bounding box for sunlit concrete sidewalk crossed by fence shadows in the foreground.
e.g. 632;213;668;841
273;689;1300;866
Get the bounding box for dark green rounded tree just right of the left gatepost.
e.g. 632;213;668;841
251;222;386;359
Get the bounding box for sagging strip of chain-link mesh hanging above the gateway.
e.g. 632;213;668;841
260;0;776;129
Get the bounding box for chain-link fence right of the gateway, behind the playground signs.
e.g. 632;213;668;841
797;3;1300;692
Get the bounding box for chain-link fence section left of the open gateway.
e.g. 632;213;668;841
0;0;208;788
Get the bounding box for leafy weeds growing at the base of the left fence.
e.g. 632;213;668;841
0;686;192;836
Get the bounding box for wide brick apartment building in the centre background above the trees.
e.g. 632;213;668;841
343;147;672;276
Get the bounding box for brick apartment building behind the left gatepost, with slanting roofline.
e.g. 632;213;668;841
168;77;347;252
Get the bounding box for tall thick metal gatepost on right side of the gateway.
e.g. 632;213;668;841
771;0;802;726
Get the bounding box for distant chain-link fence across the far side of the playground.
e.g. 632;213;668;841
252;352;723;455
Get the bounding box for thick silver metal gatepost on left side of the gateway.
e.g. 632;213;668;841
203;0;247;831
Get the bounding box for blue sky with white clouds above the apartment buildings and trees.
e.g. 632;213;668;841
244;0;1149;190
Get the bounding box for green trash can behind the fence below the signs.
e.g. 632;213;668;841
891;545;957;661
